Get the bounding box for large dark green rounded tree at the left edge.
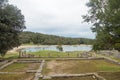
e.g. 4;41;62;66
0;0;25;56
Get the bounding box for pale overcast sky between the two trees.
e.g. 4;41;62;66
9;0;95;38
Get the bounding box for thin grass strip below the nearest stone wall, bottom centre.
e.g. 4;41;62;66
39;76;95;80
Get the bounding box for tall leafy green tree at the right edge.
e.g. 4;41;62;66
83;0;120;50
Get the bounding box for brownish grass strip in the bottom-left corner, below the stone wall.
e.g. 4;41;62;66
0;73;34;80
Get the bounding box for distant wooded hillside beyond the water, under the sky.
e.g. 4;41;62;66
19;31;94;45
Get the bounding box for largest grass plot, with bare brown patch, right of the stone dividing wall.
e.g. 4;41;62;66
43;60;120;75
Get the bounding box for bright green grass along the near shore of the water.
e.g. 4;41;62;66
0;50;83;59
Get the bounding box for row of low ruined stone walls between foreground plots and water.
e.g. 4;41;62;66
19;51;93;58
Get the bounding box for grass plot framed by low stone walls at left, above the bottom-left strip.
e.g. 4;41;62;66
0;63;40;72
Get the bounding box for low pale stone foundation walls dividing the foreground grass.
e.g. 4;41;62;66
0;57;120;80
